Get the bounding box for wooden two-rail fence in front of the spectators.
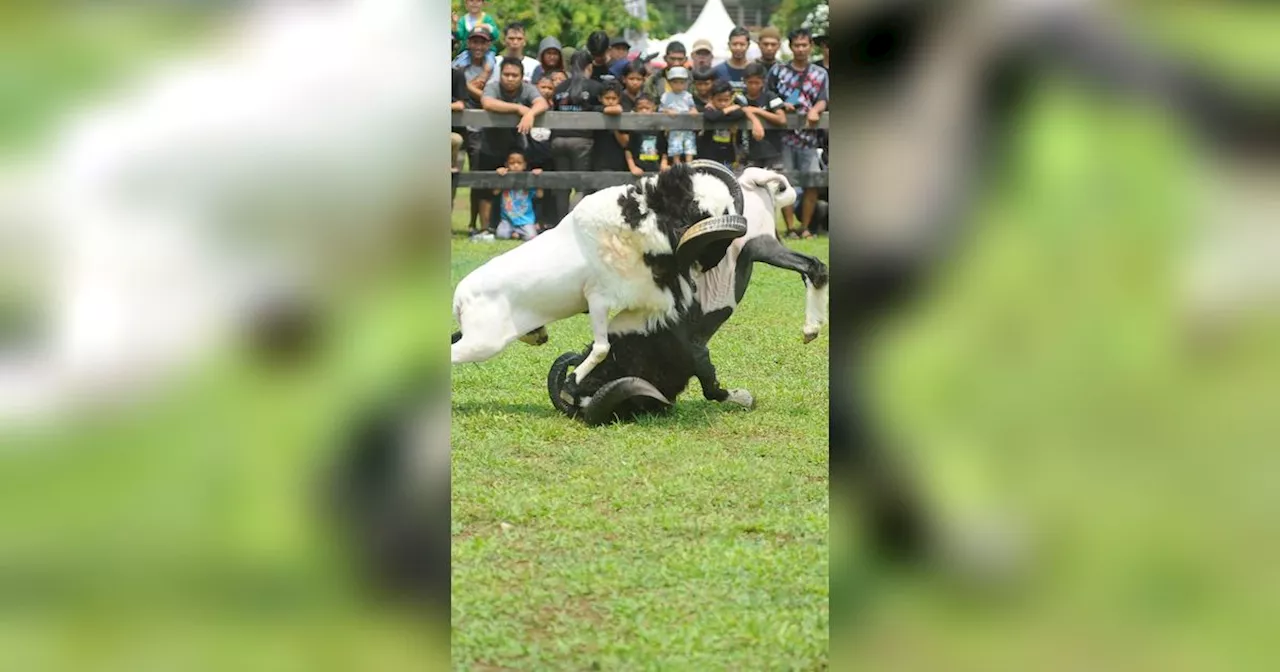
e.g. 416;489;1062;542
452;110;829;189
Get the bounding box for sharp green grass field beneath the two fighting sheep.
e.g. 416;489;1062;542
452;201;828;669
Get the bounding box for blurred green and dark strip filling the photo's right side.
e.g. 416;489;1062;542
831;1;1280;671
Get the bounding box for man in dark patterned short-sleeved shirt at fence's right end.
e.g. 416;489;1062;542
773;28;827;238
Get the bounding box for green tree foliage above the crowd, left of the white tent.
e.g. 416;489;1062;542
451;0;646;50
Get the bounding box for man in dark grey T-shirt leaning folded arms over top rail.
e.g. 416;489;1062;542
472;58;548;239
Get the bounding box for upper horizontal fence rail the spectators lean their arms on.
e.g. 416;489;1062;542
451;110;829;131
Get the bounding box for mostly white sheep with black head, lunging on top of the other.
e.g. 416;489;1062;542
452;161;746;380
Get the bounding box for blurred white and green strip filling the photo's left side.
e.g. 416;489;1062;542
0;0;449;671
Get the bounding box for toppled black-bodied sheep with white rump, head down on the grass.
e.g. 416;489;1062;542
547;168;828;425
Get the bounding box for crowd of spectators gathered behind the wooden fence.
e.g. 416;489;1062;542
452;0;831;239
